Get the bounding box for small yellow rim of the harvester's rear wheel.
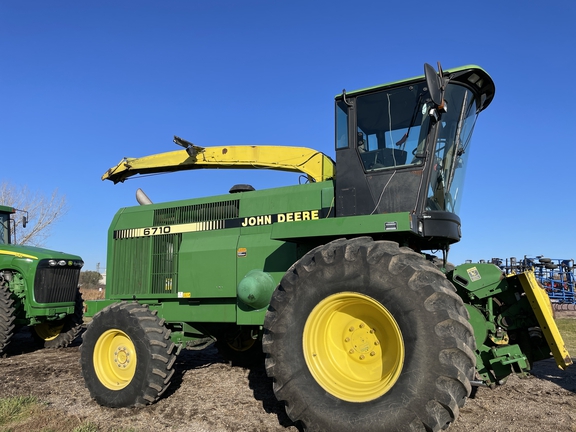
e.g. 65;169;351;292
94;329;136;390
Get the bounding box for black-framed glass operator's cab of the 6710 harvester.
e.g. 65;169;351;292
335;65;495;249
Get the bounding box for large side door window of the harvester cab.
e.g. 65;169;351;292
357;83;429;172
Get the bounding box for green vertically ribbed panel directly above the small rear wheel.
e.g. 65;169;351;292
109;237;152;295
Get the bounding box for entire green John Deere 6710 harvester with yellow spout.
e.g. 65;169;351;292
81;65;571;432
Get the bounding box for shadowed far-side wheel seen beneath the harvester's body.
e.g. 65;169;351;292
216;326;264;367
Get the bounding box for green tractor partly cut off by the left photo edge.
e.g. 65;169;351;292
0;206;84;354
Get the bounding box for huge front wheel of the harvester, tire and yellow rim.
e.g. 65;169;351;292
262;237;476;432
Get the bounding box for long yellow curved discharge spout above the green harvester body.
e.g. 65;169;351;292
102;136;335;183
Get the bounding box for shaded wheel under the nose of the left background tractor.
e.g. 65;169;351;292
30;292;84;348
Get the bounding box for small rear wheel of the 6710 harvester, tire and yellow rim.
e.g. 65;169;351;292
80;302;176;408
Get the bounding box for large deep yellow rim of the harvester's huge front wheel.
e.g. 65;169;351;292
303;292;404;402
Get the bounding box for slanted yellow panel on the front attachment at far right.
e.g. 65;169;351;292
517;271;572;369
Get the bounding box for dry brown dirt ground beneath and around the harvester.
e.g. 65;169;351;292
0;313;576;432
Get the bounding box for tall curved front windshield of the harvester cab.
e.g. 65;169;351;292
426;84;477;213
